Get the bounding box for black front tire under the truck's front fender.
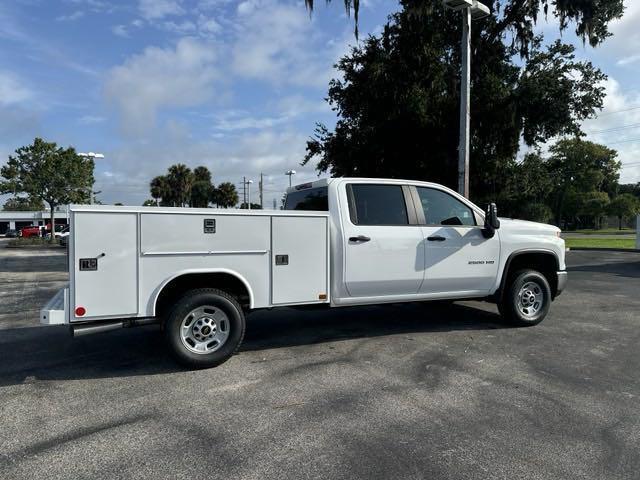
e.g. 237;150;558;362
498;270;551;327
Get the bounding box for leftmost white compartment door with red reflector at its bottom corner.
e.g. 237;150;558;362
71;212;138;321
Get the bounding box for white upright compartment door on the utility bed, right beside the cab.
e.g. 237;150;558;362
271;216;329;305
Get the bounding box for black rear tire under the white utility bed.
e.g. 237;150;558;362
164;288;245;368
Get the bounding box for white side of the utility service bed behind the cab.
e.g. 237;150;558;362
64;206;330;323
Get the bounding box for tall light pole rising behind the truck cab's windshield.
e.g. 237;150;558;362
442;0;491;198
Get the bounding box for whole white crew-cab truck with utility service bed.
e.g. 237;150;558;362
40;178;567;367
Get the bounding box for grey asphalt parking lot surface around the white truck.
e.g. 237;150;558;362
0;242;640;479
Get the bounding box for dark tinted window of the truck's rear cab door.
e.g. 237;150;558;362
349;184;409;225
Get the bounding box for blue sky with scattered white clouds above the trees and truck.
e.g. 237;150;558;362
0;0;640;205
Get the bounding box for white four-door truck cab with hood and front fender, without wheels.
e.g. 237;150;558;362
285;178;566;305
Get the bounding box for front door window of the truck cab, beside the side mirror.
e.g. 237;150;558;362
416;187;476;226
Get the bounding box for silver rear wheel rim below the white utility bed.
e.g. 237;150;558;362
180;305;230;355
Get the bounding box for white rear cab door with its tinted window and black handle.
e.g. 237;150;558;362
343;183;424;297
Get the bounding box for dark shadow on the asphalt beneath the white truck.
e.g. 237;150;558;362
0;304;507;386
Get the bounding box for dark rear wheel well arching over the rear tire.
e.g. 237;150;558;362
155;272;251;317
